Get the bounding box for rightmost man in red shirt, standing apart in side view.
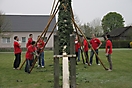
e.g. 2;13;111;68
104;35;112;71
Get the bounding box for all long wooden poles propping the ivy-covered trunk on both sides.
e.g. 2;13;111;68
19;0;108;72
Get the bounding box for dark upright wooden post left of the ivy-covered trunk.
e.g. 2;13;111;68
54;35;59;88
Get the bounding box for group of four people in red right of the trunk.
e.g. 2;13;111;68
75;34;112;71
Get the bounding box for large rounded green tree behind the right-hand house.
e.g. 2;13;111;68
102;12;125;33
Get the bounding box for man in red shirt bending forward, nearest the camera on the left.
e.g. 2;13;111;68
25;41;38;73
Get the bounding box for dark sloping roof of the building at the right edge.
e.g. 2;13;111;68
108;26;132;37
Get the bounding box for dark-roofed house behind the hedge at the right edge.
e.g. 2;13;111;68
108;26;132;40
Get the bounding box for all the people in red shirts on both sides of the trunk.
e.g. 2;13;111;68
13;34;112;73
